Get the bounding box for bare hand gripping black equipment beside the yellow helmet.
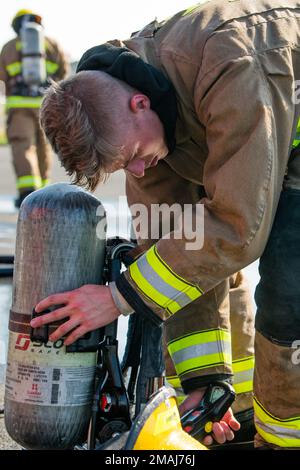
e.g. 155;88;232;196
179;388;241;446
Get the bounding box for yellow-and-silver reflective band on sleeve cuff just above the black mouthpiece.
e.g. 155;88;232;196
168;329;231;376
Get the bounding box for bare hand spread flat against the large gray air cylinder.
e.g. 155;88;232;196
30;284;120;346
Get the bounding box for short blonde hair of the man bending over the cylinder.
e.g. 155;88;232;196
40;71;135;190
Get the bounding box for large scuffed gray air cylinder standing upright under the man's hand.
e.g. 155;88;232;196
5;183;105;449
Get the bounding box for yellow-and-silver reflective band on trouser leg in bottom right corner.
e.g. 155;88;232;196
253;397;300;447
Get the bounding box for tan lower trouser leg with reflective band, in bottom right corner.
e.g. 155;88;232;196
254;331;300;450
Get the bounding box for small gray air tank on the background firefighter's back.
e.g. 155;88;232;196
20;22;47;86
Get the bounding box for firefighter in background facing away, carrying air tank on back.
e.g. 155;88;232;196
0;10;68;207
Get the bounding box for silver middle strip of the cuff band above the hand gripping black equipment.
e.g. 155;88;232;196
172;341;231;364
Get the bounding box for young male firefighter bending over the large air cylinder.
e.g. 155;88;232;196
32;0;300;448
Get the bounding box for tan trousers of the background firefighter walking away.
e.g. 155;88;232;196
7;108;52;193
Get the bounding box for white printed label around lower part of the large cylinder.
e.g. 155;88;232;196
5;362;95;406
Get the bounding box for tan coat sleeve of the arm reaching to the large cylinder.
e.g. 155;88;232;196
117;51;293;321
